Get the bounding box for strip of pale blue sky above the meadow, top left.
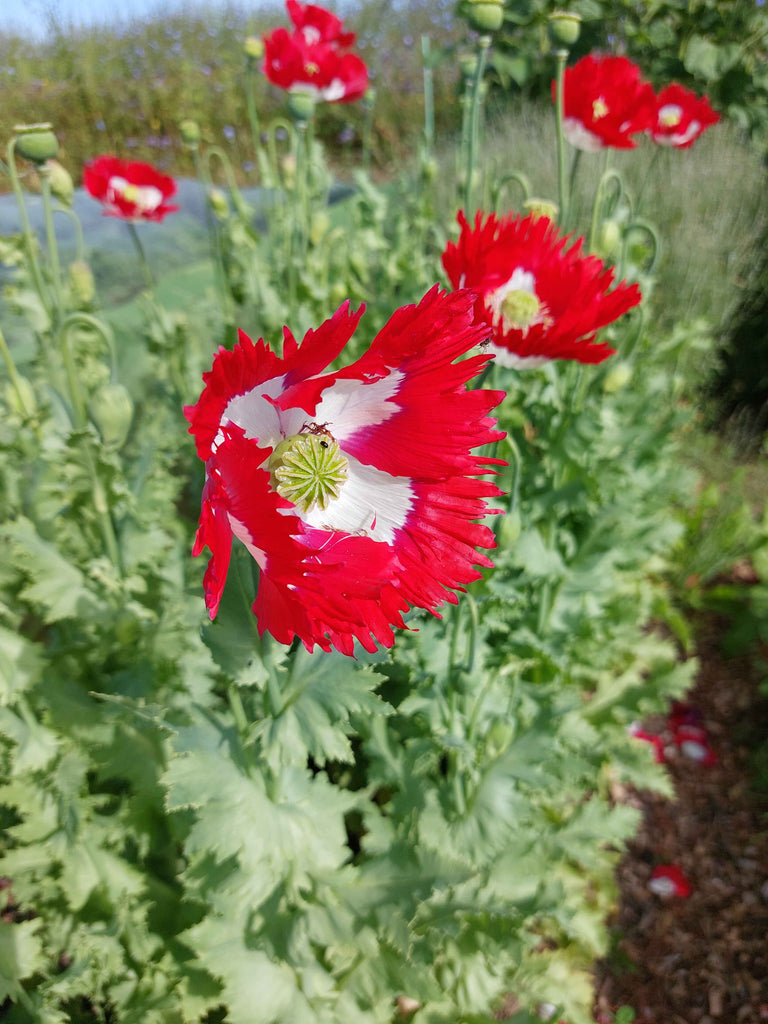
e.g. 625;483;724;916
0;0;237;39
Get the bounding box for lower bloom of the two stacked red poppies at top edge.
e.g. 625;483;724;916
264;29;369;103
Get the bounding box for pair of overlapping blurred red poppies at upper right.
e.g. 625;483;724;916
552;54;719;153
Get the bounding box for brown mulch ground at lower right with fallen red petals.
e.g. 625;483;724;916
595;618;768;1024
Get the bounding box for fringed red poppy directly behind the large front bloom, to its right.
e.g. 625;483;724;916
442;212;642;370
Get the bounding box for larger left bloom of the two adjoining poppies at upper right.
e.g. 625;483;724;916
552;54;656;153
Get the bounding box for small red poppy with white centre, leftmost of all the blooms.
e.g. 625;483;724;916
83;156;179;221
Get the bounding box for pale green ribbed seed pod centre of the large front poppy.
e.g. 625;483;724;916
267;428;349;512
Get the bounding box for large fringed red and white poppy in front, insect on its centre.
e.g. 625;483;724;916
184;286;504;654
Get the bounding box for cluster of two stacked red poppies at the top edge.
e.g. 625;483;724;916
263;0;369;103
